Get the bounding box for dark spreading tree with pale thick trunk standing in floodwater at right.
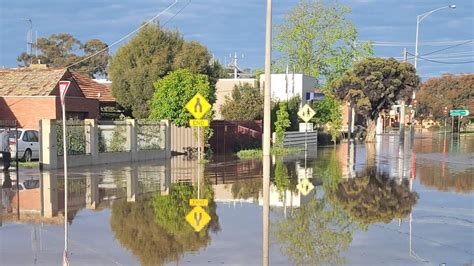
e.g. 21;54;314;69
332;58;420;142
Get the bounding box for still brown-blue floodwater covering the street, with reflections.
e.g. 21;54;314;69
0;132;474;265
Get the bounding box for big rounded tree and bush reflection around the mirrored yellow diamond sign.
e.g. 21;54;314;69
110;180;219;265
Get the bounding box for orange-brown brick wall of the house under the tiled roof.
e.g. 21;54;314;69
0;96;100;129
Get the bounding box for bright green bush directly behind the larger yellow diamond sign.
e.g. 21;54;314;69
150;69;215;126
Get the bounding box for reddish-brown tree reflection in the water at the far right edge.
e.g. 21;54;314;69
418;166;474;193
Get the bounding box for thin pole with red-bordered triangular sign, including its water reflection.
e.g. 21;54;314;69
58;80;71;262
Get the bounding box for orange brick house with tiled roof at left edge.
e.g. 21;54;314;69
0;65;115;129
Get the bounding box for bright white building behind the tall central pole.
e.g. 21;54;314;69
260;74;317;105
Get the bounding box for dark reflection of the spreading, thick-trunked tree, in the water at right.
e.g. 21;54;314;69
330;169;418;225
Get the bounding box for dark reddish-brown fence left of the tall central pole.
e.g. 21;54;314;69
209;120;263;154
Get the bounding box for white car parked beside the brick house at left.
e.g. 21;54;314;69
9;128;40;162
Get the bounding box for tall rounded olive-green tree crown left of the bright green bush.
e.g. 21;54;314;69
109;25;183;118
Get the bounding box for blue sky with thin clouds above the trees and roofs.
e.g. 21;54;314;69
0;0;474;79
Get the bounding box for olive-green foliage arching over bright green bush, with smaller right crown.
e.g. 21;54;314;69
109;24;223;118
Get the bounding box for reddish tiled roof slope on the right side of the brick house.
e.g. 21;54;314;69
71;71;116;103
